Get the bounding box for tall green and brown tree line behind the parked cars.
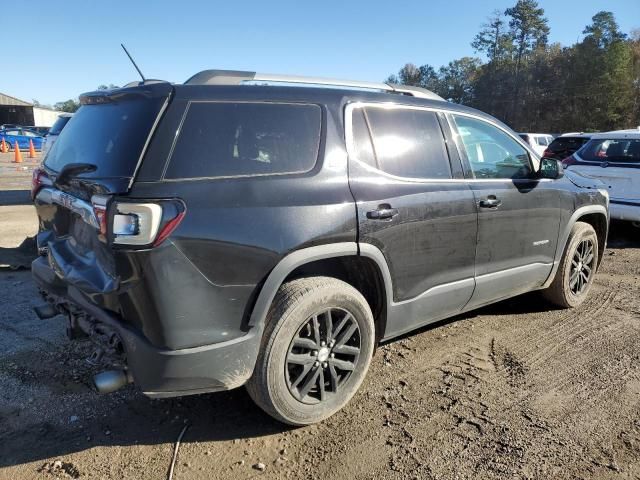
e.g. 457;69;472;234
386;0;640;132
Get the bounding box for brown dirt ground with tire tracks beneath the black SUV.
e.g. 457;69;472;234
0;201;640;480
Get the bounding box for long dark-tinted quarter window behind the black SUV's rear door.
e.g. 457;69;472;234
165;102;322;179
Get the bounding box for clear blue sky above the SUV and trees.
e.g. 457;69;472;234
6;0;640;104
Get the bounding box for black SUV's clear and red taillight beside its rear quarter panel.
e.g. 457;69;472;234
110;200;186;247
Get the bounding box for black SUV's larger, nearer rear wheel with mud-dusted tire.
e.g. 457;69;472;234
246;277;375;426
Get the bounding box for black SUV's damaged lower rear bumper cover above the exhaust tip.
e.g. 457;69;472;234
31;257;260;397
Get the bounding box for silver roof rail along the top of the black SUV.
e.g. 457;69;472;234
184;70;444;101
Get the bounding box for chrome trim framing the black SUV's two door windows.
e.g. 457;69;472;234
344;102;553;183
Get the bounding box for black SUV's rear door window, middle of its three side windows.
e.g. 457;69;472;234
365;107;451;179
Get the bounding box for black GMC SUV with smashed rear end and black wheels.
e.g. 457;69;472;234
32;71;608;425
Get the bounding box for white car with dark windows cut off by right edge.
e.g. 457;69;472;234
562;127;640;226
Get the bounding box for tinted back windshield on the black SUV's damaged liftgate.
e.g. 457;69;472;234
44;97;164;178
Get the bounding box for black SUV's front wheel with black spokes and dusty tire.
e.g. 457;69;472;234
542;222;598;308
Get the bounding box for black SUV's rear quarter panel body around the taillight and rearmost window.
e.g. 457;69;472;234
118;92;357;348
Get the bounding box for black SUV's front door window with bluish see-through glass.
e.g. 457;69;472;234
453;115;533;178
